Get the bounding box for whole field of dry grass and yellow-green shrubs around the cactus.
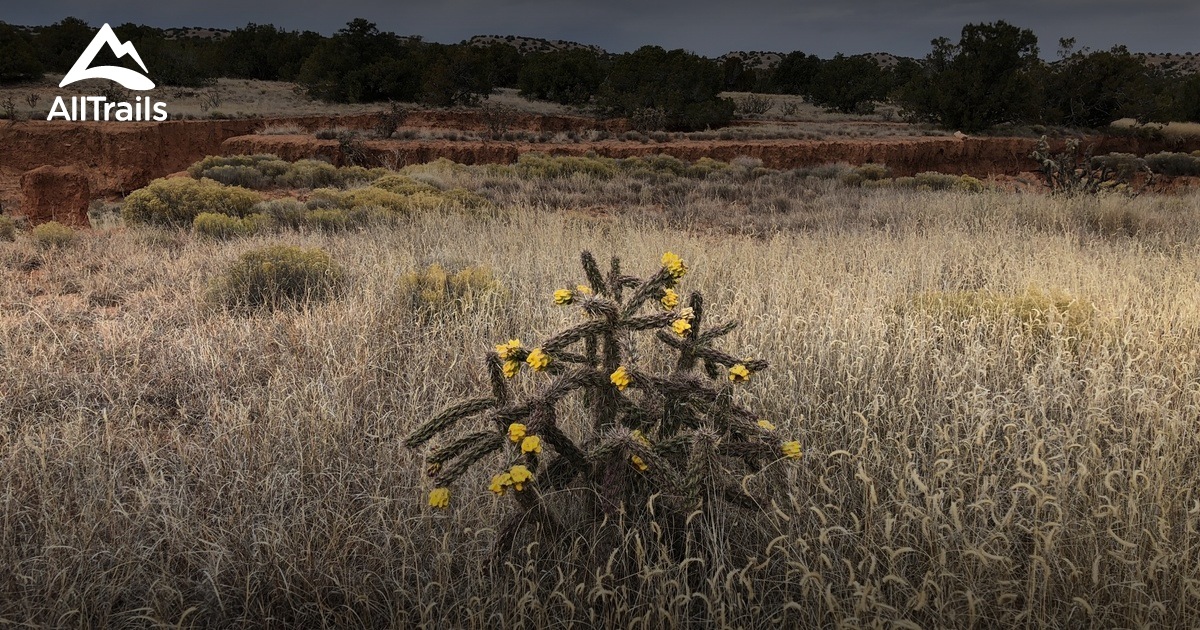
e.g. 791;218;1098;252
0;156;1200;628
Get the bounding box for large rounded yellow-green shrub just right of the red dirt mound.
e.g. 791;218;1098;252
121;178;260;226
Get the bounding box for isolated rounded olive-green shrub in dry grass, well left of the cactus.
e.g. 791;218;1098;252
210;245;344;311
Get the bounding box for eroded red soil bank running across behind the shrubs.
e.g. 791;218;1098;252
0;112;1200;212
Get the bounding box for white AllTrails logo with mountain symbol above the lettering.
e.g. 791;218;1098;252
46;24;168;122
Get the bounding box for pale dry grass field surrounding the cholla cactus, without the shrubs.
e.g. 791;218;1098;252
0;173;1200;628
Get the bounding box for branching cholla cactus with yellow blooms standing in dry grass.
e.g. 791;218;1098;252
406;252;800;541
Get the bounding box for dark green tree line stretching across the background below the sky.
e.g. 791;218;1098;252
0;18;1200;131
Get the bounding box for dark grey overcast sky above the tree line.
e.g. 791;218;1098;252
0;0;1200;58
